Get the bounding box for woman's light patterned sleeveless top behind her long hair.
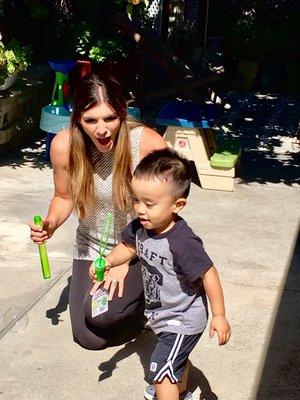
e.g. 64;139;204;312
73;126;144;260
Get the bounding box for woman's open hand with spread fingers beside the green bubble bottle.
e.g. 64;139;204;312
89;263;129;301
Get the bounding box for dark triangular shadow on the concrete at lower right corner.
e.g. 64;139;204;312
256;227;300;400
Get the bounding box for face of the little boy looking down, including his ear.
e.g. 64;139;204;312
131;177;186;233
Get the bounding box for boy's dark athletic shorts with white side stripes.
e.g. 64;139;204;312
149;332;203;383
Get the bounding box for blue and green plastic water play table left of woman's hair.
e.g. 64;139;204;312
40;60;76;161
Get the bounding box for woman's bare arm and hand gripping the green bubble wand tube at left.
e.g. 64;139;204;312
29;129;73;244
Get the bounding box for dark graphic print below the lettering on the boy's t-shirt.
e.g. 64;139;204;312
141;259;163;310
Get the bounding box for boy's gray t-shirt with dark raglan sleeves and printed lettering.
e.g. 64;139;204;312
121;218;213;335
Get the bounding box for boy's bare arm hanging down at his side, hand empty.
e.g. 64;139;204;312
203;266;230;346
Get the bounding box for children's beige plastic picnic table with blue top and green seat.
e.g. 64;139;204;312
156;102;240;191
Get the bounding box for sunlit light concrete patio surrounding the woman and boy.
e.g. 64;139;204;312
0;94;300;400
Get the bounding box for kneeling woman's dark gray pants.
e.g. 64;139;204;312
69;259;145;350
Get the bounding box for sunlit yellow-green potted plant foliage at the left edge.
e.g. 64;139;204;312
0;39;31;85
